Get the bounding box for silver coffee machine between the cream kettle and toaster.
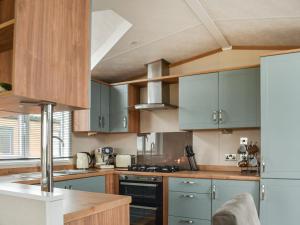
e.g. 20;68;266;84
95;147;114;169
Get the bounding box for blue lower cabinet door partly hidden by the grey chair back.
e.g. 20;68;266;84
212;180;259;215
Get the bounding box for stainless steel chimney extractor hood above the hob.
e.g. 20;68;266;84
135;59;177;110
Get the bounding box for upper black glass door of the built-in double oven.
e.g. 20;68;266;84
120;181;162;207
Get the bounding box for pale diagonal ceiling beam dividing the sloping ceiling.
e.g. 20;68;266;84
185;0;231;50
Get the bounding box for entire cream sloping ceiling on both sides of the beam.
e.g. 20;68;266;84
92;0;300;82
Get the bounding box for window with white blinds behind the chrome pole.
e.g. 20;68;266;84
0;112;71;160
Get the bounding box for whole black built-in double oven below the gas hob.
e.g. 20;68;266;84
119;175;163;225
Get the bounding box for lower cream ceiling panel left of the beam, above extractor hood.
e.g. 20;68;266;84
93;25;219;82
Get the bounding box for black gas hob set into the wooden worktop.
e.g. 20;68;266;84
128;164;179;173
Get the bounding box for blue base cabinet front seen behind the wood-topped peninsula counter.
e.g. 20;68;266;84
54;176;105;193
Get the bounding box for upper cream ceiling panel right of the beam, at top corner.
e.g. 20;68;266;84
200;0;300;20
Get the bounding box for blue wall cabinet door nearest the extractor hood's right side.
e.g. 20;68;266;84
179;73;219;130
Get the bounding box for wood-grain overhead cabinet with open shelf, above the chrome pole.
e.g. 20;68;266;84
0;0;90;113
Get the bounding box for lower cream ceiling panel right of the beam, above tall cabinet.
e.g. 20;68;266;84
217;18;300;46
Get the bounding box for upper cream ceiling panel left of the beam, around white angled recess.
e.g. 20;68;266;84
93;0;200;58
